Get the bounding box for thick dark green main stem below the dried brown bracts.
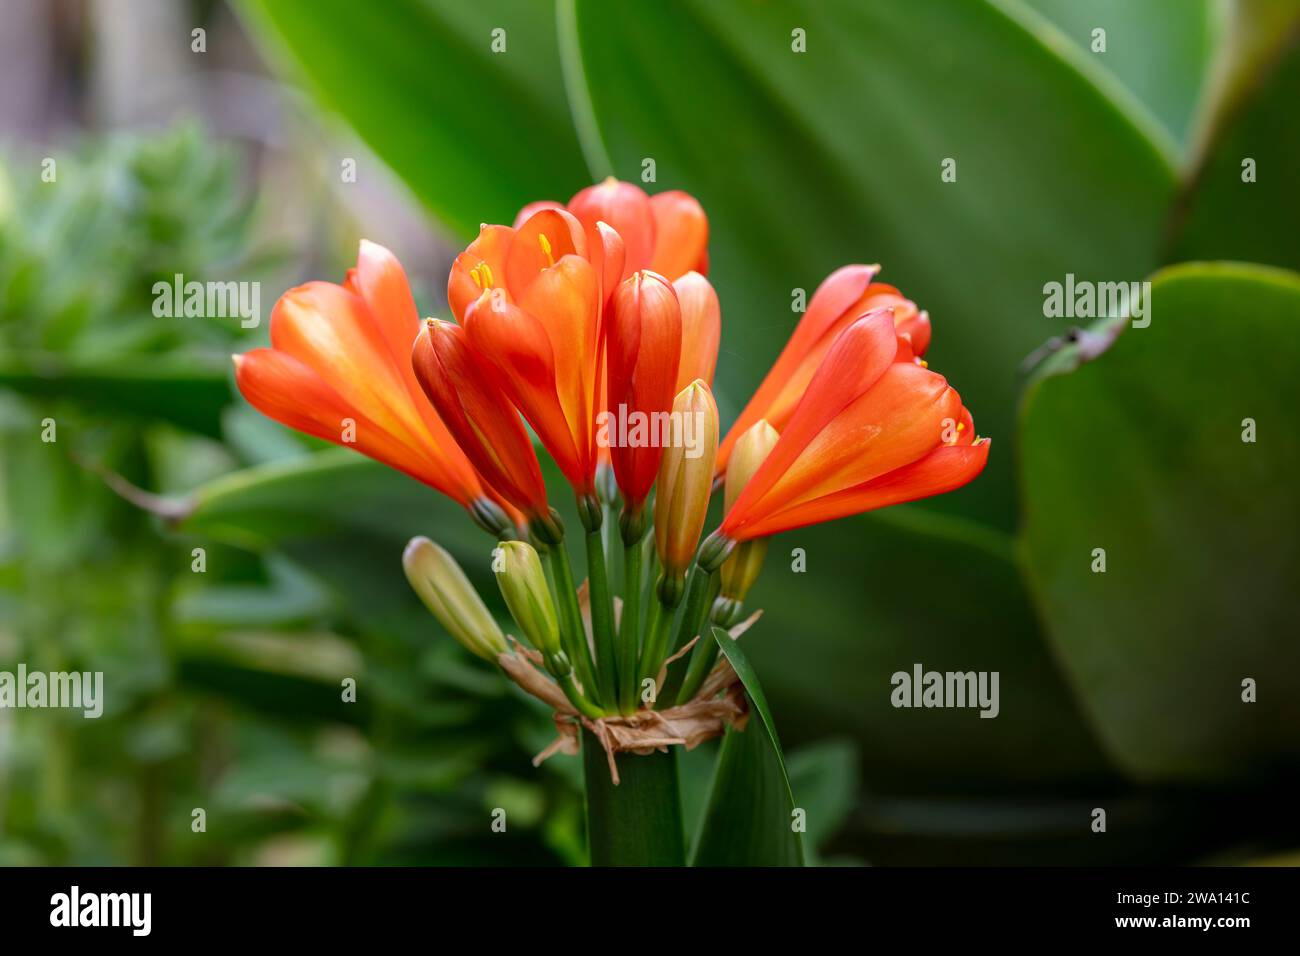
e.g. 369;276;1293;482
582;730;686;866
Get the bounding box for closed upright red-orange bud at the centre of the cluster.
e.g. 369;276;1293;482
601;272;683;515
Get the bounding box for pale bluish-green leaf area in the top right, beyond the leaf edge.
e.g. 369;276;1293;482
1026;0;1219;143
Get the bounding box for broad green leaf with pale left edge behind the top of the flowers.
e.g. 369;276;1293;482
560;0;1174;528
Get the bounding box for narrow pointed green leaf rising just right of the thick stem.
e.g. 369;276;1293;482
692;627;803;866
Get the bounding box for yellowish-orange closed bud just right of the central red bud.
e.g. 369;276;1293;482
654;378;718;580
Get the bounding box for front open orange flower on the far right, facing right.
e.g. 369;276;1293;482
720;310;989;541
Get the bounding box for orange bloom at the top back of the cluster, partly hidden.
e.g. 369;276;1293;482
515;177;709;280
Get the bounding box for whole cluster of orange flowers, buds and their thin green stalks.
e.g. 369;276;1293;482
235;179;989;738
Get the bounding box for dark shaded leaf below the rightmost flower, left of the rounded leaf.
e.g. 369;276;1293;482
745;512;1108;793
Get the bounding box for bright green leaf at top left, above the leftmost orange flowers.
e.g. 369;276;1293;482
239;0;586;235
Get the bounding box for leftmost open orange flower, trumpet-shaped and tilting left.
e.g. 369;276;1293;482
234;241;504;520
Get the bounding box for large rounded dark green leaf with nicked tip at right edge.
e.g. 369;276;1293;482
1022;265;1300;780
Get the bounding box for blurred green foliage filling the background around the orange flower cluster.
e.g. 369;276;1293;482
0;0;1300;864
